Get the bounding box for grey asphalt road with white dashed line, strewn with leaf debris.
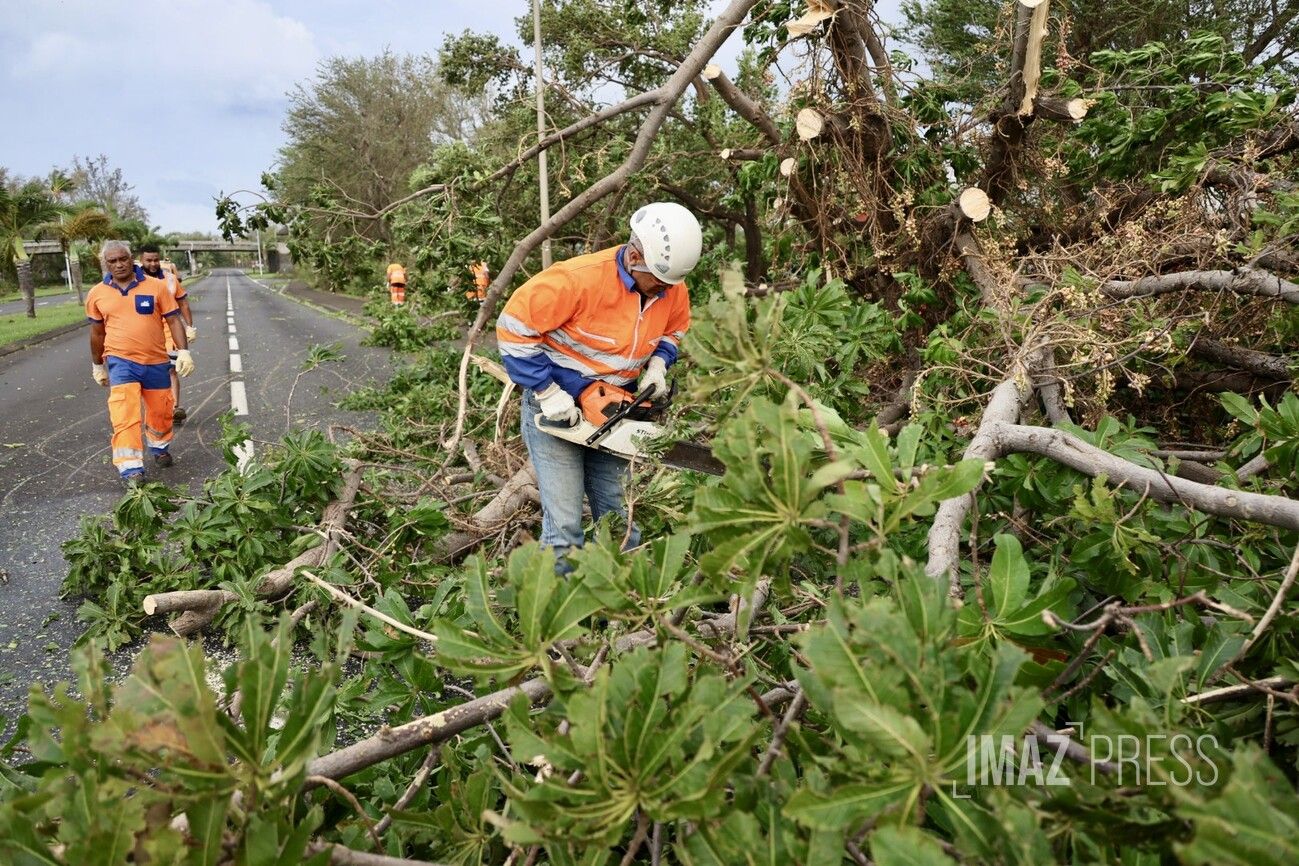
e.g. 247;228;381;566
0;270;394;728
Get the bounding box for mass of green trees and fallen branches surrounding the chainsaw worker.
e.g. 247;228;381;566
0;0;1299;866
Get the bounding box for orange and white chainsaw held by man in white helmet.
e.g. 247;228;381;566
534;382;726;475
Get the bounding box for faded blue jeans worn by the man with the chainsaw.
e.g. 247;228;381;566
520;390;640;570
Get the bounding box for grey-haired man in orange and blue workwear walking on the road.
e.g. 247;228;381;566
86;240;194;484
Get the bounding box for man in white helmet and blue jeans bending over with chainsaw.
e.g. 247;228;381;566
496;201;703;573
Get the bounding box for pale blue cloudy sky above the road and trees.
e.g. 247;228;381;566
0;0;896;232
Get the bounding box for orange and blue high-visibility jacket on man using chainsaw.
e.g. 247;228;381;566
496;247;690;397
